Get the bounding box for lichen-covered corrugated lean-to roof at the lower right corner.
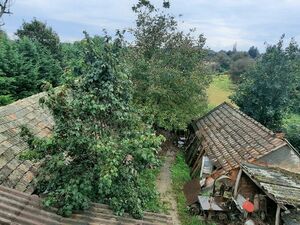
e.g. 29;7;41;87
242;163;300;207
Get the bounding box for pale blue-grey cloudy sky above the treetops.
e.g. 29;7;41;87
4;0;300;50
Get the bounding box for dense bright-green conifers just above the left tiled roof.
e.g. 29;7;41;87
0;32;63;105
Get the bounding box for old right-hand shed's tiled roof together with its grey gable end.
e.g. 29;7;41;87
186;102;300;181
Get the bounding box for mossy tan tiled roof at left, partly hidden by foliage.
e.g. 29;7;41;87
0;93;53;193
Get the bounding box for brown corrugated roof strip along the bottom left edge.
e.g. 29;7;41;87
0;185;172;225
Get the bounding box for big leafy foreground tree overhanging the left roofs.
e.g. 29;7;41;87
23;35;162;217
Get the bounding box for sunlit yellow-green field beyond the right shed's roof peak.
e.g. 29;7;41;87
207;75;234;108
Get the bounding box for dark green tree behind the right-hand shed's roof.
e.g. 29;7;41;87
232;37;299;129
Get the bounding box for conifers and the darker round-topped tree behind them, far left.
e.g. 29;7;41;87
0;19;63;105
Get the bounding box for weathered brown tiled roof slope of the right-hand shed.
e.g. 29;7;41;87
193;102;287;171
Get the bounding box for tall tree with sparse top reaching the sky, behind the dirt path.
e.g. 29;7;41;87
129;0;209;130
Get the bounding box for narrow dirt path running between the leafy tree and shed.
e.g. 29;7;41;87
157;144;180;225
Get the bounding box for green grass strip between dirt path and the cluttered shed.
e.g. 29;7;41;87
171;152;203;225
